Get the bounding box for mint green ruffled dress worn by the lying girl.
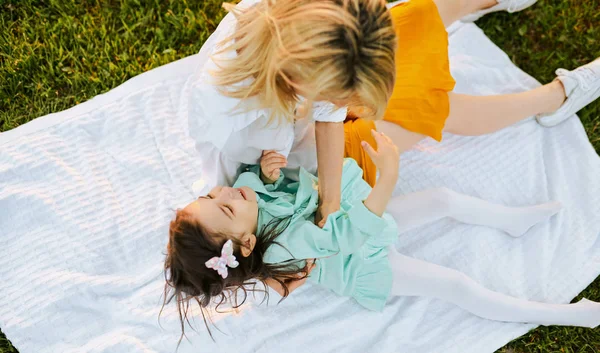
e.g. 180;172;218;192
234;159;398;311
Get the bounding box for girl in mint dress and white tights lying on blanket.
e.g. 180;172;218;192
165;131;600;340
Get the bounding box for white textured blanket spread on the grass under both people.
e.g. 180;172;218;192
0;24;600;353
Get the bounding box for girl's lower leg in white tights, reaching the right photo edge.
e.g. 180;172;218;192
389;248;600;328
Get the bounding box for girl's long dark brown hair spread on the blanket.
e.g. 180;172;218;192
159;210;306;345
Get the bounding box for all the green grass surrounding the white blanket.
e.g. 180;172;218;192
0;0;600;353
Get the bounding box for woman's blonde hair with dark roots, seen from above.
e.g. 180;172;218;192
212;0;396;121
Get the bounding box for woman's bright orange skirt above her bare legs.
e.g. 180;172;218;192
344;0;455;186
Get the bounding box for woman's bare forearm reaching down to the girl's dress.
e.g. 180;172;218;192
315;121;344;227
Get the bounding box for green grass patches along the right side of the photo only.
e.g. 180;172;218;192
478;0;600;353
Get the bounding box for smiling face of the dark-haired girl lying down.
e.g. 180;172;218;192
184;186;258;256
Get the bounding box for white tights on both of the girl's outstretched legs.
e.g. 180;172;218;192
387;188;600;327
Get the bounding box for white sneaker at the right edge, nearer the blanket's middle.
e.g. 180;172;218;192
536;58;600;127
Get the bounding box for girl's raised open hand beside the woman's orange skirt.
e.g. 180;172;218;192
361;130;400;180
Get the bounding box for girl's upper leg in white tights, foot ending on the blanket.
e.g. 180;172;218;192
386;188;561;237
